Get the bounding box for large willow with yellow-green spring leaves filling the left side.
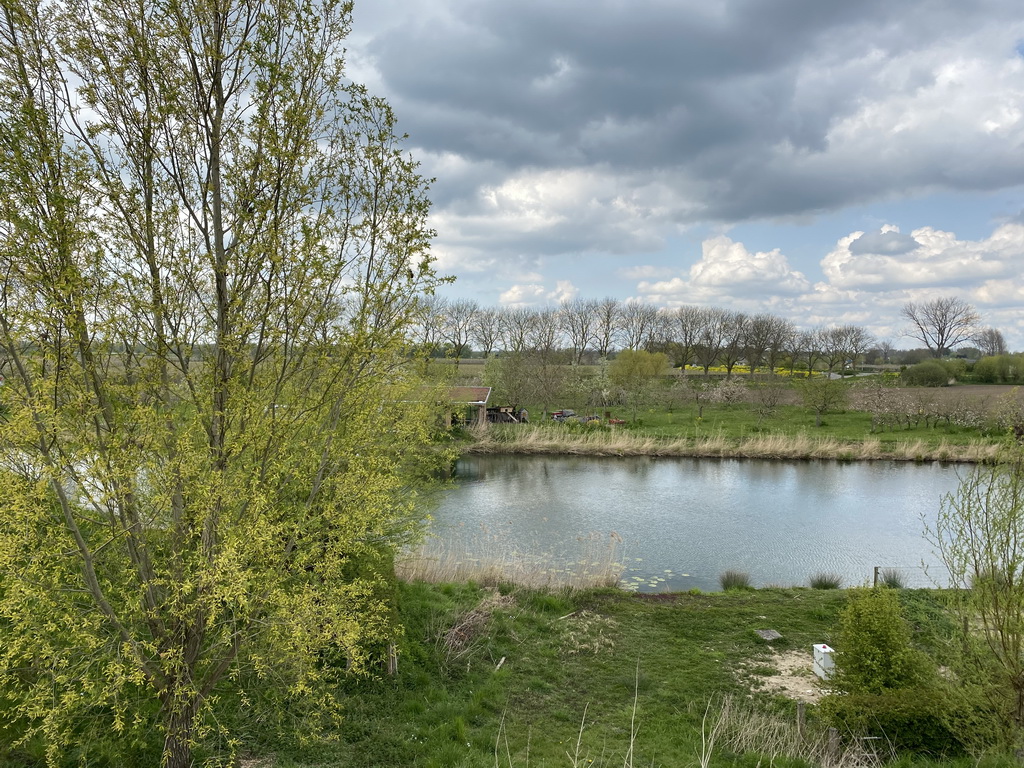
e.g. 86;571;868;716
0;0;444;766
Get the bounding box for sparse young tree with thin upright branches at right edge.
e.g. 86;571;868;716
925;450;1024;745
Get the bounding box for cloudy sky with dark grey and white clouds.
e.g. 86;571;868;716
347;0;1024;350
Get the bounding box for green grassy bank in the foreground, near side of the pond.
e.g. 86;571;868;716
234;584;1007;768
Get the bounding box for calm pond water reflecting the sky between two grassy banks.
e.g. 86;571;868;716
419;456;968;591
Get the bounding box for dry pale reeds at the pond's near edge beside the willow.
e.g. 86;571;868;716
395;531;625;589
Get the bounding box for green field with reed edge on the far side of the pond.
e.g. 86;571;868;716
449;360;1024;462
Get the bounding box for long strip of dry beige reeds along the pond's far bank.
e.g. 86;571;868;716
467;425;1000;463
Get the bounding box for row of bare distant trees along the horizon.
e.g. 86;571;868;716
416;296;1007;374
